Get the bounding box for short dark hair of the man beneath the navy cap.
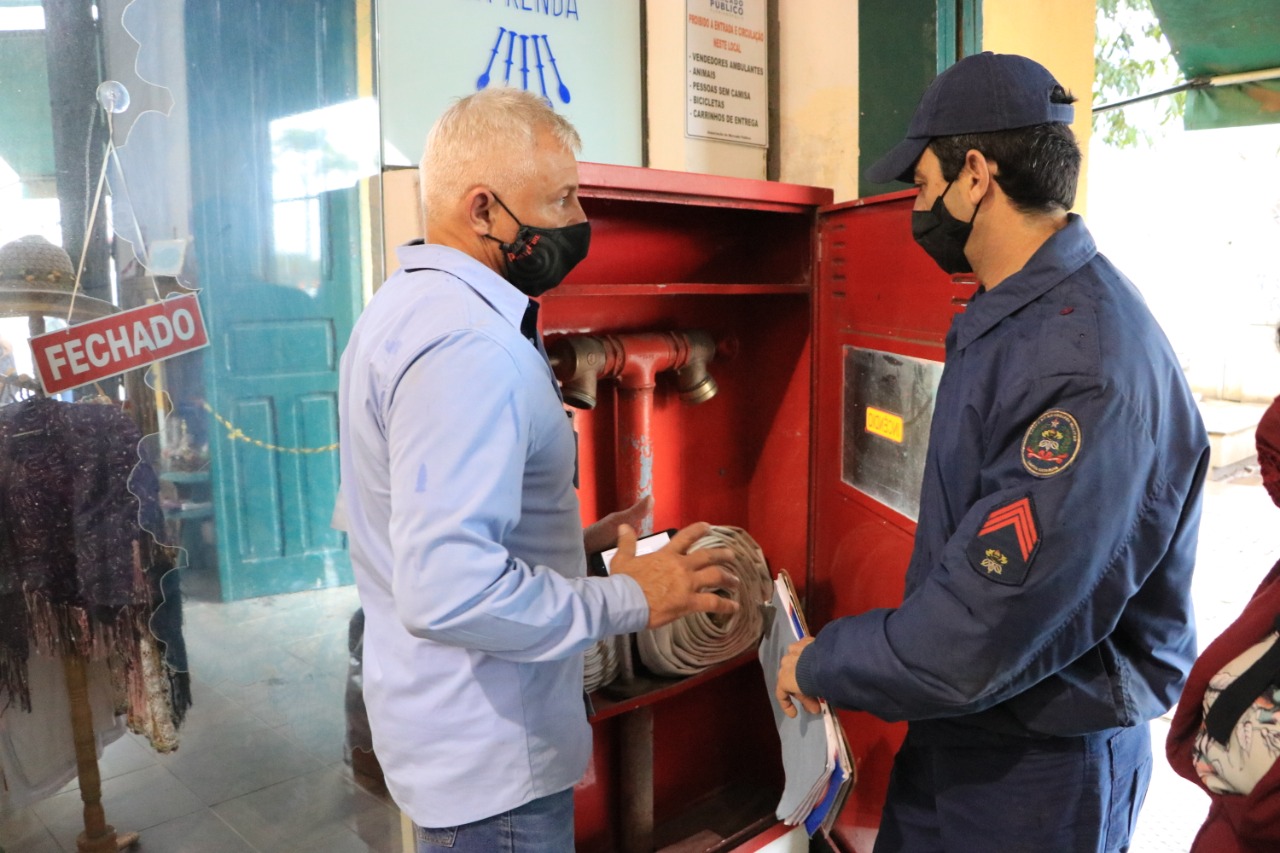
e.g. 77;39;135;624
929;86;1080;213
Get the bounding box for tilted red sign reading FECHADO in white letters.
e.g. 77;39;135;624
31;295;209;394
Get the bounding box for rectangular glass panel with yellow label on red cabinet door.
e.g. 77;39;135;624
841;347;942;521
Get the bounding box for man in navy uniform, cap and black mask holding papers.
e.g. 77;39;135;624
778;53;1208;853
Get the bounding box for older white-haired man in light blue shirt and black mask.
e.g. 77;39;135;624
339;88;736;853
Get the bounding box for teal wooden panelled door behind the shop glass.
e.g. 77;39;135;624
186;0;378;599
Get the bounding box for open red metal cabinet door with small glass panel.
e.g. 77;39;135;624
806;191;975;850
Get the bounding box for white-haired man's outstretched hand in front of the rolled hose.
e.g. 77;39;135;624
609;521;739;628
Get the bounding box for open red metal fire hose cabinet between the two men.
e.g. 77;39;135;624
388;163;974;853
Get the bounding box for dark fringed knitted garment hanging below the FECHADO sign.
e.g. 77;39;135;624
0;398;191;751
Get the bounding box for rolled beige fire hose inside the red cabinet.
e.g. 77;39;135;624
584;525;773;693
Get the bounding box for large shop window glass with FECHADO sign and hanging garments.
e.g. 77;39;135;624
0;0;401;853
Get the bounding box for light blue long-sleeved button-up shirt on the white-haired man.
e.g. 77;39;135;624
339;245;649;826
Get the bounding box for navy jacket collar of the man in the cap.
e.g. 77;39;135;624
954;214;1098;350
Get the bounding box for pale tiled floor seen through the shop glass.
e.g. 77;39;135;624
0;584;401;853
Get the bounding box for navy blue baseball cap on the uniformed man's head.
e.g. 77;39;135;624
867;51;1075;183
